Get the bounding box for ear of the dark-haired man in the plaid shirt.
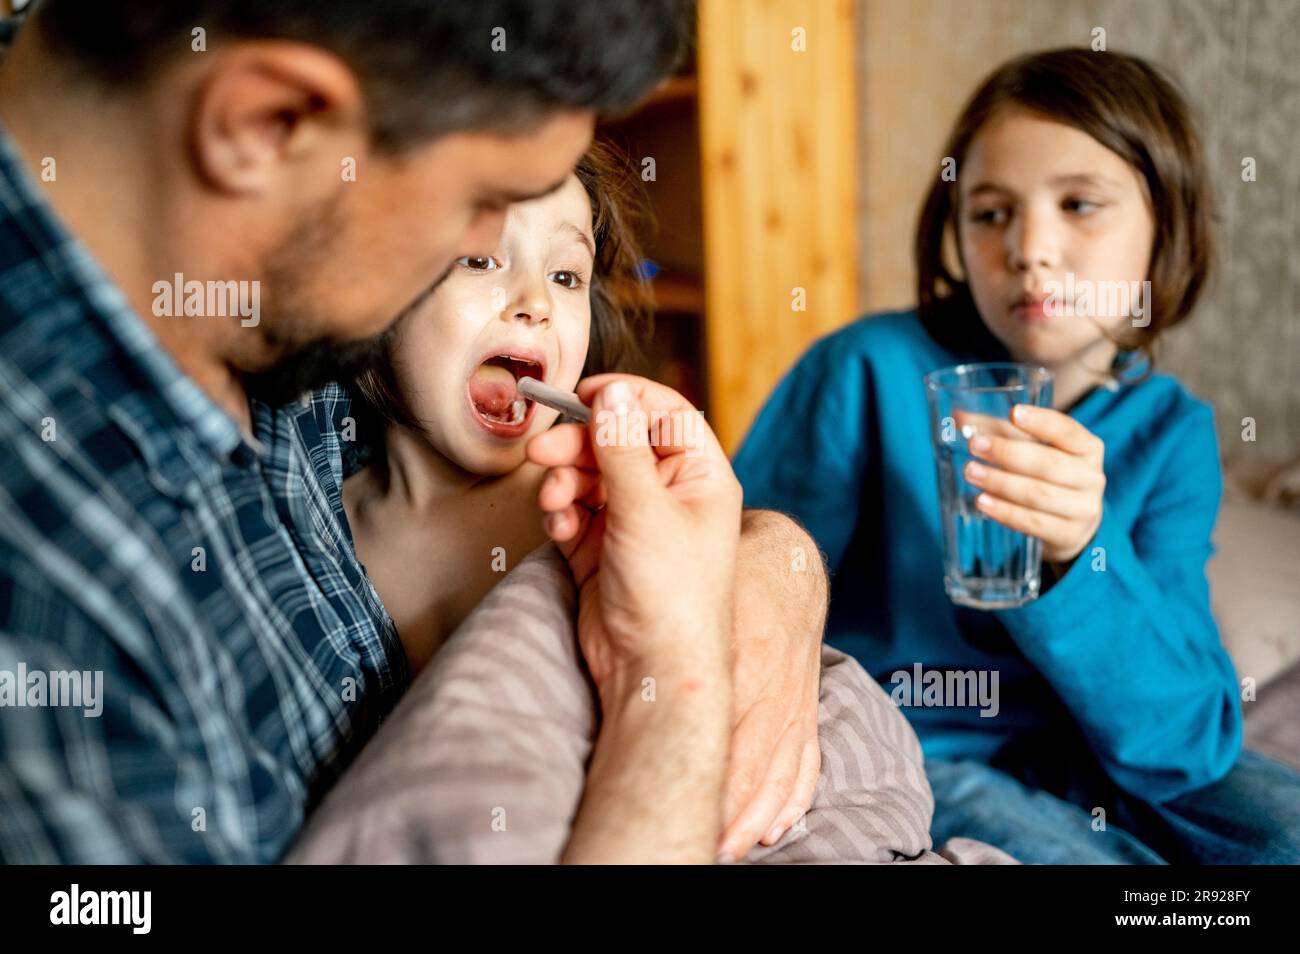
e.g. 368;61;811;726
190;42;369;196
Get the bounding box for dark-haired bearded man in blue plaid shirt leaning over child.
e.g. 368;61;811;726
0;0;824;862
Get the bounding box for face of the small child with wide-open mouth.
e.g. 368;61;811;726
393;175;595;476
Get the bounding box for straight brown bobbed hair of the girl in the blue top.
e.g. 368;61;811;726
914;47;1214;369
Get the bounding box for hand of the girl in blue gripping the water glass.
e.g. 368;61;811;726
962;404;1106;569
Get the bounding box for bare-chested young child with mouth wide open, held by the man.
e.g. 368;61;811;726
343;143;651;672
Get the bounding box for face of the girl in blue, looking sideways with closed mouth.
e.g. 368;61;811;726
957;110;1154;368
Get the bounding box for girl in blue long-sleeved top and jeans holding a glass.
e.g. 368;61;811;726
735;49;1300;863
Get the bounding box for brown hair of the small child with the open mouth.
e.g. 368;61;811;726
355;139;654;428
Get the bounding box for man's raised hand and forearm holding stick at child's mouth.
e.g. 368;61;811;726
528;374;741;862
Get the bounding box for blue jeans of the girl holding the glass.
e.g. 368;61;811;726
926;750;1300;864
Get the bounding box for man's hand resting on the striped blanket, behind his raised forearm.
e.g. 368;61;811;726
719;511;827;860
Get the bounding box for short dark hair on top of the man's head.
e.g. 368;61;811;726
33;0;694;151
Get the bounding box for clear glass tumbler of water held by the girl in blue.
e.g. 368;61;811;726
926;363;1052;610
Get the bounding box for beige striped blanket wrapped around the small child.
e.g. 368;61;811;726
286;546;1015;864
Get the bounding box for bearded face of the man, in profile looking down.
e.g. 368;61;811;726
244;112;594;402
